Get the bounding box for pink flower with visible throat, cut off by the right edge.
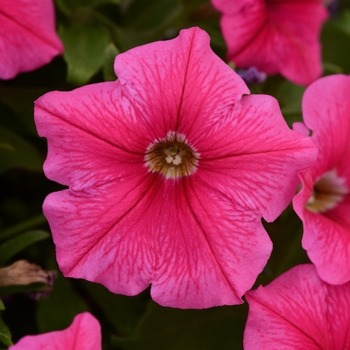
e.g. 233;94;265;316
293;74;350;284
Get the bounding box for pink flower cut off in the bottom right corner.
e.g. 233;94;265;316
244;264;350;350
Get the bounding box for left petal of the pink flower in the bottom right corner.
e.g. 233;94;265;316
244;265;333;350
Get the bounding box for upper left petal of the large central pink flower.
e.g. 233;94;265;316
34;82;152;190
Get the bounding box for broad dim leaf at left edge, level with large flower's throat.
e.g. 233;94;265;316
0;126;43;173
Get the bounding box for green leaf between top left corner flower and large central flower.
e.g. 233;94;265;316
59;22;110;85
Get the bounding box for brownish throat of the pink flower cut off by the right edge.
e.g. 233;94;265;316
305;169;349;213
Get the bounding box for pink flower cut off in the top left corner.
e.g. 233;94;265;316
0;0;63;79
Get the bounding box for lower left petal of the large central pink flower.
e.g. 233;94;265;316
43;182;156;295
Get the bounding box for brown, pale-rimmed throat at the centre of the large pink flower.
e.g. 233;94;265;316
144;131;200;179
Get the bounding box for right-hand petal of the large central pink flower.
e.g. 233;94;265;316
197;95;317;221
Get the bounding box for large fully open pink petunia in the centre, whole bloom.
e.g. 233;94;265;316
35;28;316;308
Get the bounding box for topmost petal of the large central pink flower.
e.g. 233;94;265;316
115;28;249;140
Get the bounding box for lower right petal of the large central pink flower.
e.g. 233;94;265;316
151;179;272;308
